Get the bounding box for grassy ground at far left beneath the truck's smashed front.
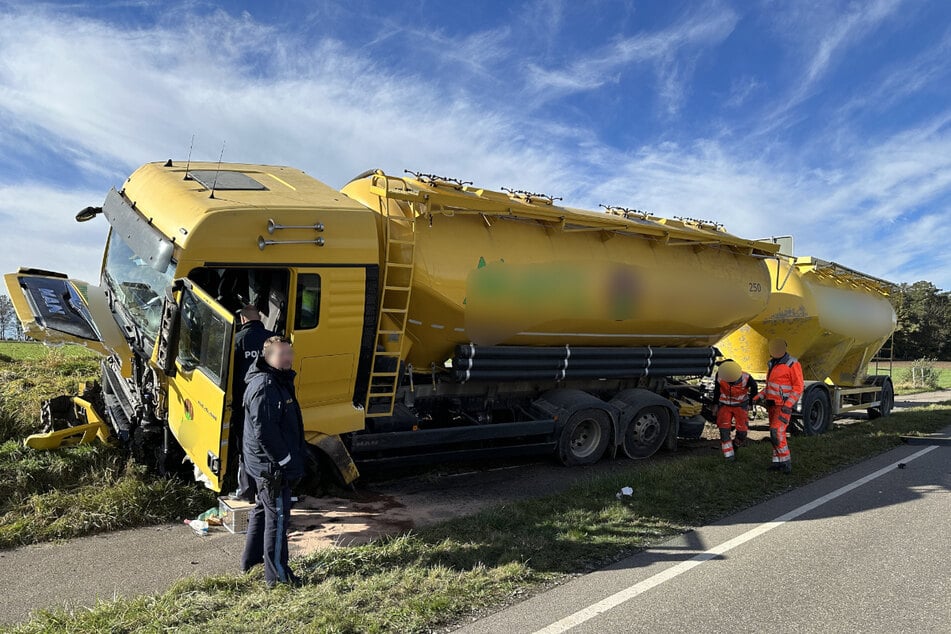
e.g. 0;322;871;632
0;342;215;549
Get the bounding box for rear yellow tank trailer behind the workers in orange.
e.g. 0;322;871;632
717;256;895;434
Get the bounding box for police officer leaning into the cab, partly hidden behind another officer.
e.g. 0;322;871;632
231;304;274;502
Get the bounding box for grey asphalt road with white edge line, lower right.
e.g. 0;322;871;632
459;429;951;634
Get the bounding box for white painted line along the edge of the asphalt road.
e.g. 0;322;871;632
535;446;937;634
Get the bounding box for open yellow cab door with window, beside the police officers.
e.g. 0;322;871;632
164;279;234;491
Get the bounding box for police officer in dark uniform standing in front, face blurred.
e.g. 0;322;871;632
241;337;307;586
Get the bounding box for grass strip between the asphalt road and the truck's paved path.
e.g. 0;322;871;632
16;401;951;632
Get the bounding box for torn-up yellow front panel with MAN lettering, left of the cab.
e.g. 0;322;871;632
4;269;132;366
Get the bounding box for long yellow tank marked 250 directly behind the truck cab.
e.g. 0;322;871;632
342;172;777;369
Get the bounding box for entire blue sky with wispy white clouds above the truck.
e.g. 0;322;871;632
0;0;951;289
